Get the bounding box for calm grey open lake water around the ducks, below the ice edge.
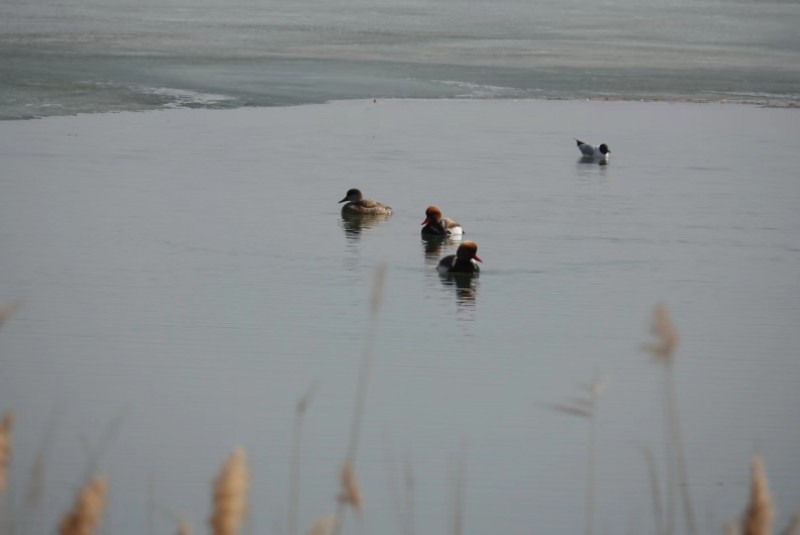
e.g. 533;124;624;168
0;99;800;534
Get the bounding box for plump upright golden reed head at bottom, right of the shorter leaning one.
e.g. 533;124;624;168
209;448;248;535
